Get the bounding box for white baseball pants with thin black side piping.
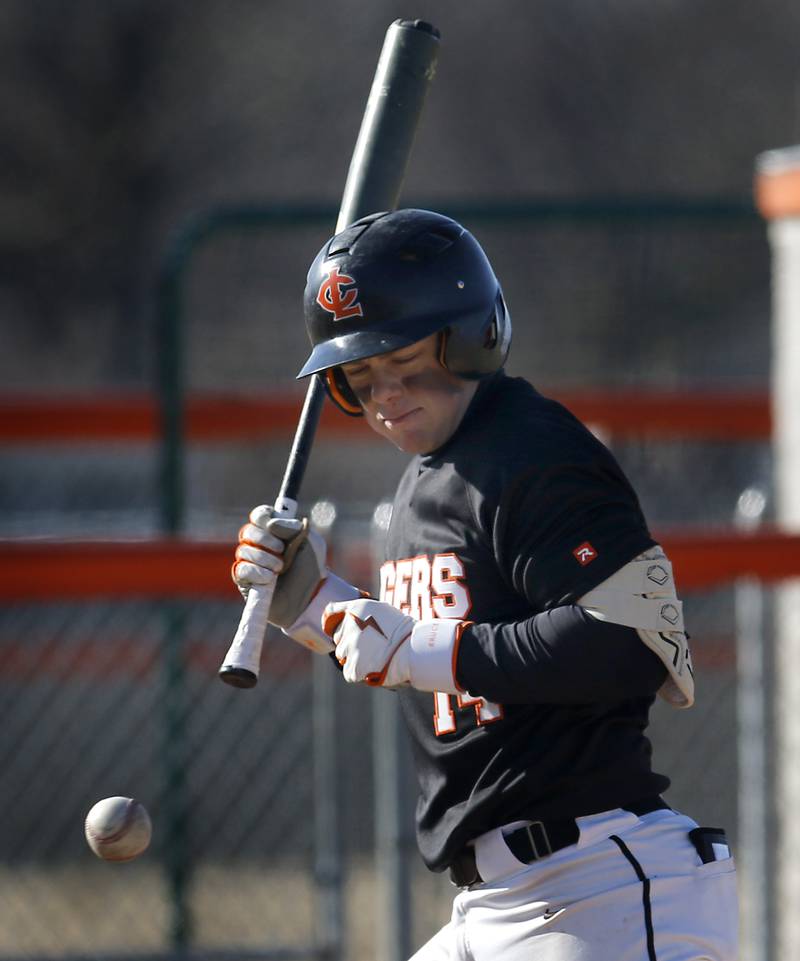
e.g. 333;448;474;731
411;809;738;961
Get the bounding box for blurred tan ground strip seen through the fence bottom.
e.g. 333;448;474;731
0;860;453;961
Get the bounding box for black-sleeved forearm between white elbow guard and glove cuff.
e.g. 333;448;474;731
456;606;666;704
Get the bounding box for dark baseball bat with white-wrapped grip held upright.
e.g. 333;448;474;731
219;20;439;688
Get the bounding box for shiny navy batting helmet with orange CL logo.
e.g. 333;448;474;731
297;210;511;415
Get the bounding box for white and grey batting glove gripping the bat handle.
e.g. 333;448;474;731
231;504;360;654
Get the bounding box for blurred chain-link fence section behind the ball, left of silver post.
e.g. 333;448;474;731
0;599;324;957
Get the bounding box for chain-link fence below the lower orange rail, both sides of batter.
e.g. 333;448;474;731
0;514;772;961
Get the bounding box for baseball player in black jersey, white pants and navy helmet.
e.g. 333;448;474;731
233;210;737;961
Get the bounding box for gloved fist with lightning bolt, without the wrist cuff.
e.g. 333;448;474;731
322;599;417;687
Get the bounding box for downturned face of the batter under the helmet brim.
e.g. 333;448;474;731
342;334;477;454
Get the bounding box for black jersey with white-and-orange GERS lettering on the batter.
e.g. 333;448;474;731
381;371;669;871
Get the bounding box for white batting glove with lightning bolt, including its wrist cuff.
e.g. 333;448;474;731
322;599;469;694
